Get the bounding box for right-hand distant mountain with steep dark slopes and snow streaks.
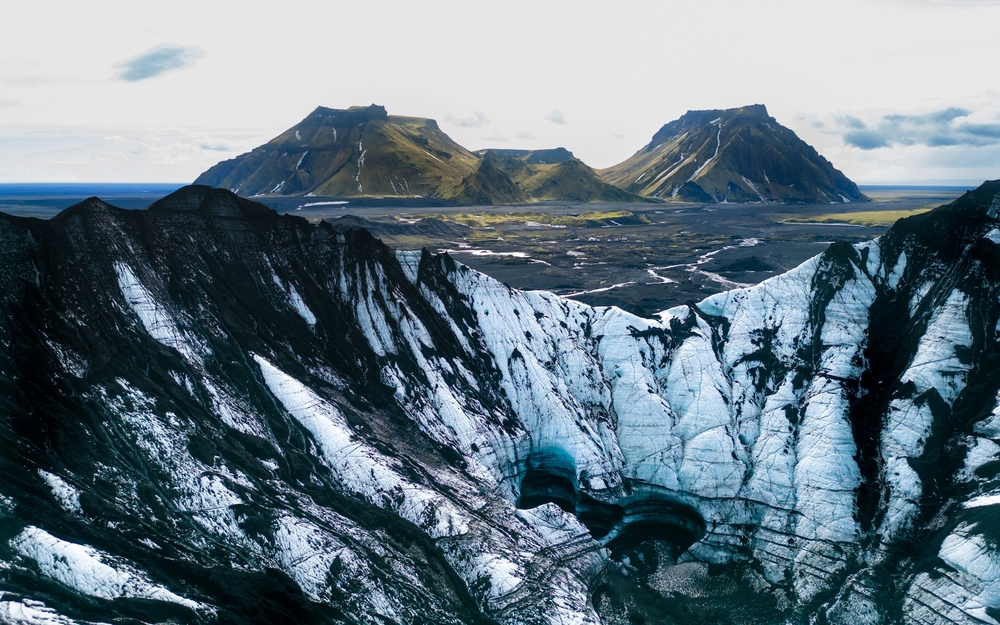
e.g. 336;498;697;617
599;104;869;203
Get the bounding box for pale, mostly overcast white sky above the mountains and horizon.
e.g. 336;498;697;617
0;0;1000;184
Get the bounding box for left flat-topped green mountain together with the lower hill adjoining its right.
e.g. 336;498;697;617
195;104;645;205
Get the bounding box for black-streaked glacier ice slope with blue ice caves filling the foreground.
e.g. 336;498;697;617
0;182;1000;625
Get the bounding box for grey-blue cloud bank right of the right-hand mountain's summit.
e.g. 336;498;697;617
833;106;1000;150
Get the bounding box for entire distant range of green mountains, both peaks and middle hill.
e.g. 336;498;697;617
195;104;868;205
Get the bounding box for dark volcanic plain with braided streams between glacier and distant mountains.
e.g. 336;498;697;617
0;187;964;315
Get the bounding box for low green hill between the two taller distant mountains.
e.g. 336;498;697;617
476;148;648;202
